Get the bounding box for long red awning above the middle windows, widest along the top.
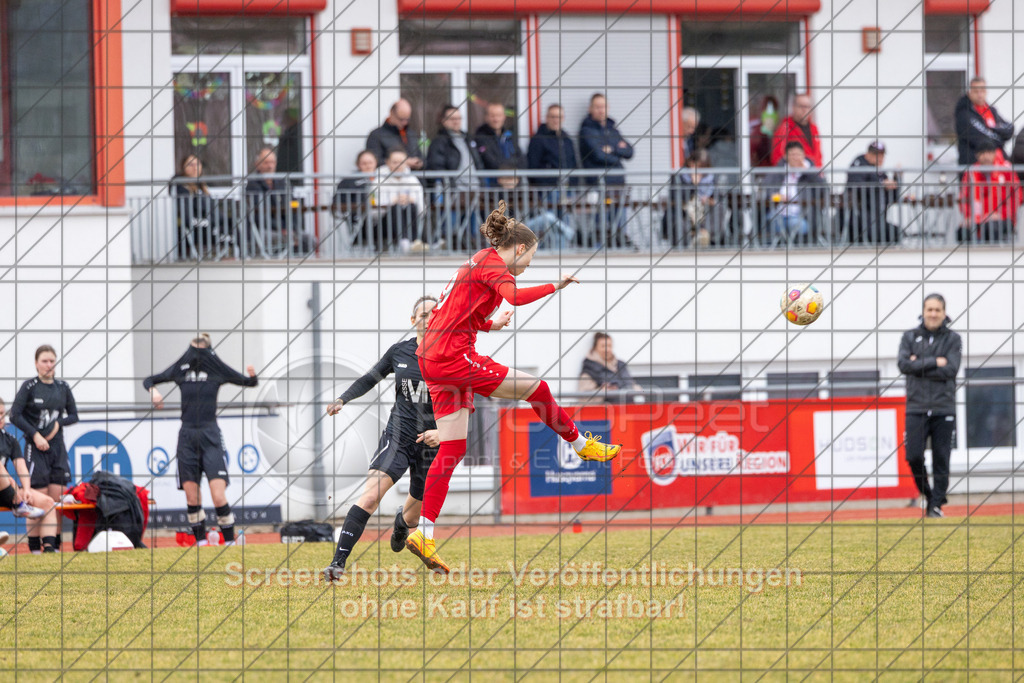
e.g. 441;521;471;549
395;0;819;15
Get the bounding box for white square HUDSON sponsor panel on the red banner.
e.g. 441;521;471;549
814;410;899;490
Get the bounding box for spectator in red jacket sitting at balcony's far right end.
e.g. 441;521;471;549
956;140;1021;243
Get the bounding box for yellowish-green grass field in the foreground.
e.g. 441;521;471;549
0;517;1024;681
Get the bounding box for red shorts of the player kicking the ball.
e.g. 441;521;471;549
420;353;509;418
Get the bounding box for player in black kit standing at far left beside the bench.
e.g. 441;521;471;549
10;344;77;553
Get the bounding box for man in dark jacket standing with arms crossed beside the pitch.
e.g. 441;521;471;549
899;294;962;517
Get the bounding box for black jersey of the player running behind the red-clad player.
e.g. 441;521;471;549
339;338;437;442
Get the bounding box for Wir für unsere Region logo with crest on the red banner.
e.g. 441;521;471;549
640;425;790;486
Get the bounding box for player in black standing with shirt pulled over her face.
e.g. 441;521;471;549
142;333;258;546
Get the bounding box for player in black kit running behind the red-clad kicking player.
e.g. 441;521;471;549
324;296;440;581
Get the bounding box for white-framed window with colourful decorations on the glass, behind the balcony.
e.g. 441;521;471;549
169;16;313;181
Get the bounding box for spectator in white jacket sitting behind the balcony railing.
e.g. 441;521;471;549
377;147;426;253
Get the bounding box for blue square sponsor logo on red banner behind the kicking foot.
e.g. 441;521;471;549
529;421;611;498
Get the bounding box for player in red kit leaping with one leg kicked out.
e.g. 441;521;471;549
406;202;622;573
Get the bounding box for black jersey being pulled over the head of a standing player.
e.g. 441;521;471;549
142;346;257;427
